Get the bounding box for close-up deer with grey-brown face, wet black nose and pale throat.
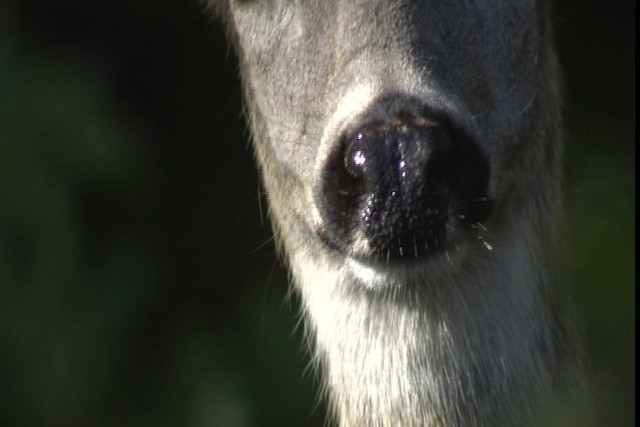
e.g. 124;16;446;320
212;0;577;426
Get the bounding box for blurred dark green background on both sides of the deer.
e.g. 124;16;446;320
0;0;635;427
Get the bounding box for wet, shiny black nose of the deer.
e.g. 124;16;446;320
319;107;492;260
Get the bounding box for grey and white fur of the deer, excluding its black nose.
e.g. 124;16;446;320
208;0;577;426
